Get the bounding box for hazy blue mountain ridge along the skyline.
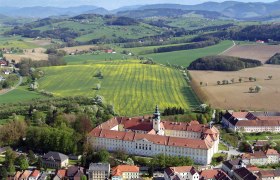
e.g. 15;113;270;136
0;0;280;20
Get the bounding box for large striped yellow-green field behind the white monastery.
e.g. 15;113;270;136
39;60;199;116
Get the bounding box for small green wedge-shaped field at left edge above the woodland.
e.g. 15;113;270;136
0;87;44;104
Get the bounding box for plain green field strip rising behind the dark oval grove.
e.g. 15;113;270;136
145;41;233;67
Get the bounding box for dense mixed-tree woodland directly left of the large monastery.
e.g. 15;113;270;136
0;96;116;154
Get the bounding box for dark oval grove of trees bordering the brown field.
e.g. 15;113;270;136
188;56;262;71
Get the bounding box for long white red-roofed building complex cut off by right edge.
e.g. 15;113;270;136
222;112;280;133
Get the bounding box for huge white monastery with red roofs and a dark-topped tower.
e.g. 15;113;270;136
88;106;219;164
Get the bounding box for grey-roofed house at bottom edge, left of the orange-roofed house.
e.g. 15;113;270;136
88;163;110;180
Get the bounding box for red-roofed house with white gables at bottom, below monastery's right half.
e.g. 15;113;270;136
164;166;199;180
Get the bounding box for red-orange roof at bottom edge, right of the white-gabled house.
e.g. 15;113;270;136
200;169;231;180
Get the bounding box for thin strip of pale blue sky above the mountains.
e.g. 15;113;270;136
0;0;276;10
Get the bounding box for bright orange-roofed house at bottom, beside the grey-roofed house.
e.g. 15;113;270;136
112;165;139;180
